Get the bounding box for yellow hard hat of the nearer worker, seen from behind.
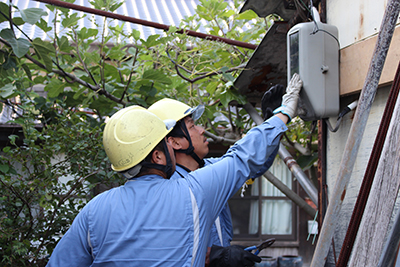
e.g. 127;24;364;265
103;106;175;172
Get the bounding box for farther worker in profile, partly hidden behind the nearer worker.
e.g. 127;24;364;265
148;96;282;267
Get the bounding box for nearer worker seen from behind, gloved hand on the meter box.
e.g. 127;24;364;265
48;75;301;267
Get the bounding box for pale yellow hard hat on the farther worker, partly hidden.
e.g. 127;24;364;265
148;98;204;121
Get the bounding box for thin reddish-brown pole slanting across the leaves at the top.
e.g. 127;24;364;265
35;0;257;50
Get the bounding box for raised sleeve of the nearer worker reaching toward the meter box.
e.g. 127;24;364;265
187;117;287;224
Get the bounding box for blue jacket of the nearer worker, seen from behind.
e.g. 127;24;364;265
48;117;287;267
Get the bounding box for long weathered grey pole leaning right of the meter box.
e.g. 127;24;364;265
310;0;400;267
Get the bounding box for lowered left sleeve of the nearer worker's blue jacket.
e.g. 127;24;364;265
46;207;93;267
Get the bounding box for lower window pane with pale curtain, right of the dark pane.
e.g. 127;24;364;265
261;200;292;235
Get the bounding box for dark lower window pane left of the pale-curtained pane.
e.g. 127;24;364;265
229;198;259;235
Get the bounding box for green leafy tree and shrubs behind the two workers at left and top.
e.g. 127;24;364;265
0;0;318;266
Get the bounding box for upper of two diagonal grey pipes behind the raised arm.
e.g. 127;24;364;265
243;103;318;206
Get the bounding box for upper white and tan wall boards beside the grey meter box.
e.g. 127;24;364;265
326;0;400;96
